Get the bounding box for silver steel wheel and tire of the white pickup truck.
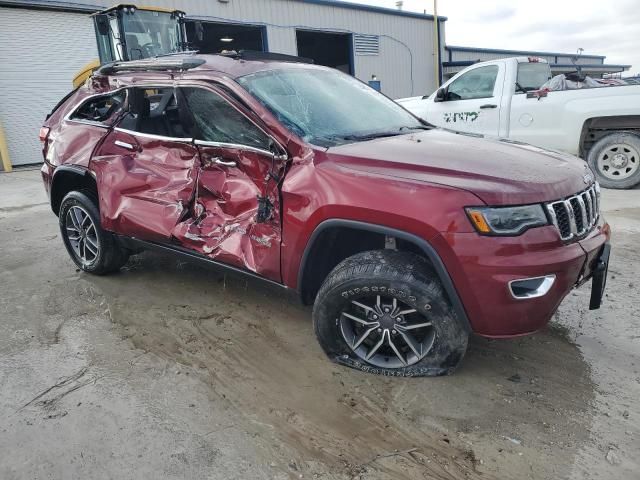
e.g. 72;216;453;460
587;132;640;189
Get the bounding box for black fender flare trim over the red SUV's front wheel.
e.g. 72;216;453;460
298;218;473;333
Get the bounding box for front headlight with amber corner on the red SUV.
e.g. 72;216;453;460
465;205;549;235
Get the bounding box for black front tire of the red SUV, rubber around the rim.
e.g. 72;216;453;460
313;250;469;376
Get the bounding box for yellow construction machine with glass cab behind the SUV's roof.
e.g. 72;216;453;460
73;4;187;88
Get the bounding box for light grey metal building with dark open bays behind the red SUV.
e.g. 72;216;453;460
0;0;446;169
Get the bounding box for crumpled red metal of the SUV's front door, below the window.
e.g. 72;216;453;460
173;146;281;281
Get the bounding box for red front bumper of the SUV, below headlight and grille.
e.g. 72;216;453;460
432;218;610;337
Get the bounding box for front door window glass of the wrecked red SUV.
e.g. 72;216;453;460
182;88;270;150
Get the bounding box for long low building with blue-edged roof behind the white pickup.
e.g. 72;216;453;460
442;45;631;79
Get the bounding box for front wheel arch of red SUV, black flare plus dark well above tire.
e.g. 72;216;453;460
298;219;472;332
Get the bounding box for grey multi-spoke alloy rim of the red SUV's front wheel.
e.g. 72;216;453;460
339;295;435;368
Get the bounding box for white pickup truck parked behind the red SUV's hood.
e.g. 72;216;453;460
397;57;640;188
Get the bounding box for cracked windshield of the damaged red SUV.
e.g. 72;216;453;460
238;68;427;147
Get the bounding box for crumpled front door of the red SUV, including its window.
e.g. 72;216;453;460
173;85;285;282
